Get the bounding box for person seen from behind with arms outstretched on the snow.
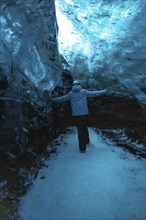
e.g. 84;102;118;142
52;80;107;153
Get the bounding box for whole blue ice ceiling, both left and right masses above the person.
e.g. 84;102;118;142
0;0;146;103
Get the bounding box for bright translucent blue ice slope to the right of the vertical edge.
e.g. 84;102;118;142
55;0;146;103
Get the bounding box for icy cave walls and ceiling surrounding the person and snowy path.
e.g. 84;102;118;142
0;0;146;220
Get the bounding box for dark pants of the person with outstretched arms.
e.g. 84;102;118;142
74;115;89;151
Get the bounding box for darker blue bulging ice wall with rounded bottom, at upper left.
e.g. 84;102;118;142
0;0;61;99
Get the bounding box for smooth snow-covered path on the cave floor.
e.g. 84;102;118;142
19;127;146;220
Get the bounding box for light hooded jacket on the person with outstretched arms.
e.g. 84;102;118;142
52;85;106;116
